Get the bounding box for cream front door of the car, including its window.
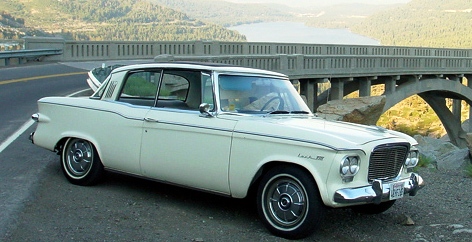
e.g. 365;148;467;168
141;70;236;194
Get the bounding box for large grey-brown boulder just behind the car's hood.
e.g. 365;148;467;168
317;96;385;125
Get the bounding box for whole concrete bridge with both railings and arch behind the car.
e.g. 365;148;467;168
8;37;472;148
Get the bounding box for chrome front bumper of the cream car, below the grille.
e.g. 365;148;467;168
334;173;424;204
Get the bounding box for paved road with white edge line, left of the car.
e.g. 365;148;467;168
0;63;87;238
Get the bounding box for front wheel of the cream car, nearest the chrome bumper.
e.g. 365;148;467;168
257;167;325;239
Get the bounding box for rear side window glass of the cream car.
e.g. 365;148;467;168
118;71;160;106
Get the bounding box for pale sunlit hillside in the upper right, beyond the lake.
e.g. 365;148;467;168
350;0;472;48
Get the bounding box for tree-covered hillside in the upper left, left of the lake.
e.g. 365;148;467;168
2;0;245;41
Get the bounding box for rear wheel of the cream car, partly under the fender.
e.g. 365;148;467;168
61;138;104;186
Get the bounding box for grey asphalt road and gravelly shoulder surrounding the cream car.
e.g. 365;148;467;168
0;63;472;241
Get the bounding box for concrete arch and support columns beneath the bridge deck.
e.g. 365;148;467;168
316;75;472;148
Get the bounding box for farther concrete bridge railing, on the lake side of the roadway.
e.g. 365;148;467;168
25;37;472;61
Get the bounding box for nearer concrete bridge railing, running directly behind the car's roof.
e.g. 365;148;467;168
155;54;472;79
